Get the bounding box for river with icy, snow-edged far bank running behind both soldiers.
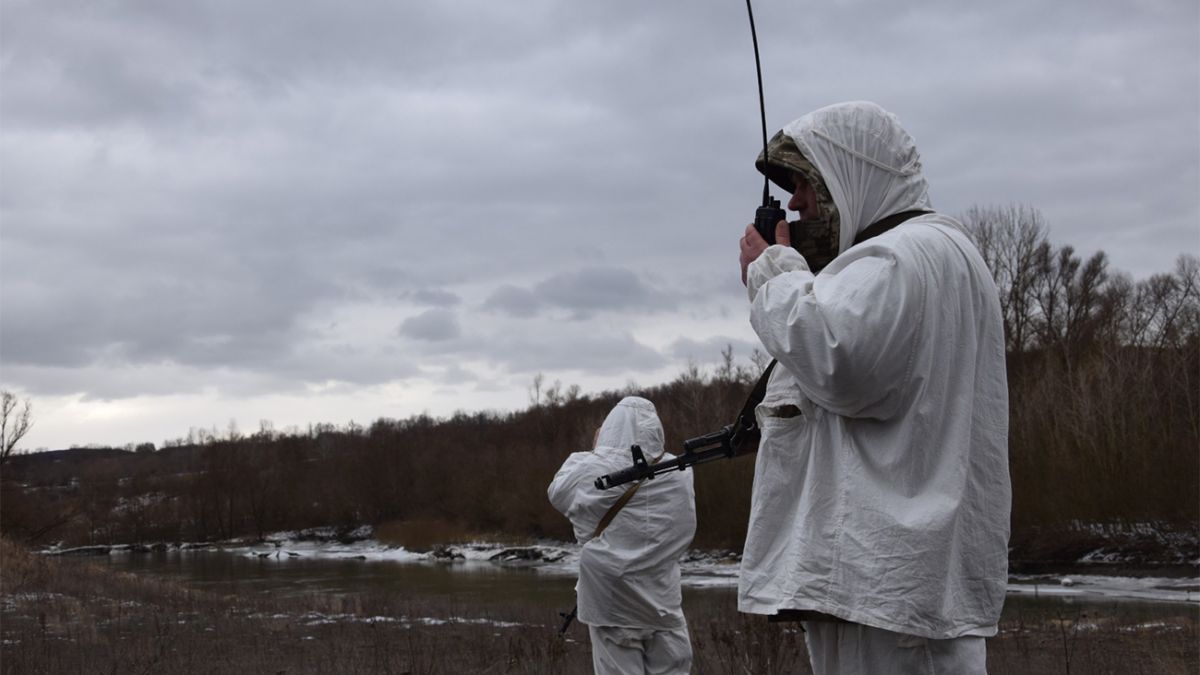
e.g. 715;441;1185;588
77;545;1200;623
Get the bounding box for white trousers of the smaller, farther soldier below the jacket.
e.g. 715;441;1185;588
588;626;691;675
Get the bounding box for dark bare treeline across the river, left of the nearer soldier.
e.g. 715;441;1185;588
0;350;757;545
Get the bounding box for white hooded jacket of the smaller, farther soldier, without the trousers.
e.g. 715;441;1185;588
547;396;696;629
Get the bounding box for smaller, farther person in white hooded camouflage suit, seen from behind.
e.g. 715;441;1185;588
547;396;696;675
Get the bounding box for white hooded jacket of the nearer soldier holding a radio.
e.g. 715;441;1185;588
738;103;1012;639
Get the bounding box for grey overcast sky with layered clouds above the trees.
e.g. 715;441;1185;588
0;0;1200;449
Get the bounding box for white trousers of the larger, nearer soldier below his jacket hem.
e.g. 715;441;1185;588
804;621;988;675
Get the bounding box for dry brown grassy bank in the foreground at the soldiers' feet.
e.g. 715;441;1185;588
0;540;1200;675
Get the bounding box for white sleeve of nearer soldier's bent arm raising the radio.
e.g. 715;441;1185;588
748;236;924;419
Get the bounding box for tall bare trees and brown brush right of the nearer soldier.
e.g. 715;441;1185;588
962;205;1200;531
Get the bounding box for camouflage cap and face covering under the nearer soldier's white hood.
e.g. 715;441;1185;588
755;131;840;271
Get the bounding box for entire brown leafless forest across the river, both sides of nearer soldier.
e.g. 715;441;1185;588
0;205;1200;549
